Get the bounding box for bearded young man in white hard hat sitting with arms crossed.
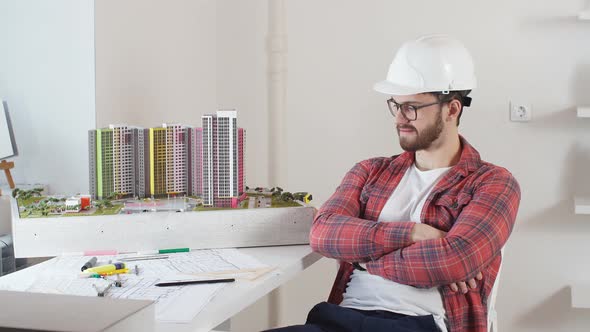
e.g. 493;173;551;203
268;35;520;332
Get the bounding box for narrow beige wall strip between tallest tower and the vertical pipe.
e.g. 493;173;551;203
215;0;270;187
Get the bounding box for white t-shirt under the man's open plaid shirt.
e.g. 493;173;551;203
340;165;450;332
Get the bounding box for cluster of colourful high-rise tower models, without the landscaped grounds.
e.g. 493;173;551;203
88;110;246;207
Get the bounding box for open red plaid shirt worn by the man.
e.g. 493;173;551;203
310;137;520;332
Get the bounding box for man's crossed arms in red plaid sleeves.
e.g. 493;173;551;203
310;161;520;287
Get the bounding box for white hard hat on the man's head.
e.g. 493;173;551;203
374;35;476;96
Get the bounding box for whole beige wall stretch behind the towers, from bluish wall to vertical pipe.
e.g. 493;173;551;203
96;0;268;186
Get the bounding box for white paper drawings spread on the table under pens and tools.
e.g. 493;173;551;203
17;249;269;323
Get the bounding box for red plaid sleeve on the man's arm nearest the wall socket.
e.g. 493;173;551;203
367;168;520;287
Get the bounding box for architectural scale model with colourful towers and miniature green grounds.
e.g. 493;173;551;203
12;110;312;218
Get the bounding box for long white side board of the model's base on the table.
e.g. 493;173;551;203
11;199;315;257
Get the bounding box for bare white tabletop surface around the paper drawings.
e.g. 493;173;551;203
0;245;321;332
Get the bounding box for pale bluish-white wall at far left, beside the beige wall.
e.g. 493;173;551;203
0;0;95;193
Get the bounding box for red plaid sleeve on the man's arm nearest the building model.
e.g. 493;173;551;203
309;160;414;262
